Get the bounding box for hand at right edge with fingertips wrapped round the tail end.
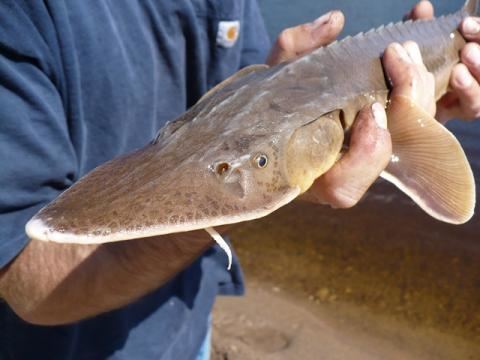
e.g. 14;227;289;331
409;0;480;123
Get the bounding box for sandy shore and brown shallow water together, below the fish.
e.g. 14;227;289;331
214;181;480;360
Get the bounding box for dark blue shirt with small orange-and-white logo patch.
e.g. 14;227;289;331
0;0;269;360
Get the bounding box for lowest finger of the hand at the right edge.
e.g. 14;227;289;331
450;64;480;119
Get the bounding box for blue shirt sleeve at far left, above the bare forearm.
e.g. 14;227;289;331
0;0;77;268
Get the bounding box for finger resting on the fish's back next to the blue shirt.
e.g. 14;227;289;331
267;11;345;65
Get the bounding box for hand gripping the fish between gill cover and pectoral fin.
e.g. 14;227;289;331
305;42;436;208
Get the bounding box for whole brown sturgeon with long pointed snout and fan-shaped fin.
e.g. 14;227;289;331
25;0;479;250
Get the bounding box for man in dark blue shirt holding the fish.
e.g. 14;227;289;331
0;0;480;359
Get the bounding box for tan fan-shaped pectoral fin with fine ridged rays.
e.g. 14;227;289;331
382;96;475;224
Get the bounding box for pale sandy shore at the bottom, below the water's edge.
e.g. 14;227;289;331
212;283;480;360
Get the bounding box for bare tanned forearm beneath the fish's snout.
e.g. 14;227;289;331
0;232;213;325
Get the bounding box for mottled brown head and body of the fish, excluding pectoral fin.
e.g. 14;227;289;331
27;2;476;243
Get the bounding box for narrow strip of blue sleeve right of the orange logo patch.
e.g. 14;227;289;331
240;0;271;67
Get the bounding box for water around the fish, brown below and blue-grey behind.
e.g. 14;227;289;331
228;0;480;359
